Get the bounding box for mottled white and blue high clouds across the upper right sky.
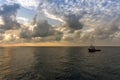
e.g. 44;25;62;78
38;0;120;24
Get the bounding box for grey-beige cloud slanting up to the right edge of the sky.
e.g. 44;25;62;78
94;15;120;39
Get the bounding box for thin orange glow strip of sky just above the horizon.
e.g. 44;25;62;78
0;42;88;47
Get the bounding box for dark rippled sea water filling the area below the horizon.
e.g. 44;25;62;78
0;47;120;80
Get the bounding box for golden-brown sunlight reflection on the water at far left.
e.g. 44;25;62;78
0;48;34;80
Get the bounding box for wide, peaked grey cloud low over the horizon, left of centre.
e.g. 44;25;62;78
20;20;62;41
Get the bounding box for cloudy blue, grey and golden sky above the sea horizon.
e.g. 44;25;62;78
0;0;120;45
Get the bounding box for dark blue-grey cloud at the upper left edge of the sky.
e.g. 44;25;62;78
0;4;20;30
